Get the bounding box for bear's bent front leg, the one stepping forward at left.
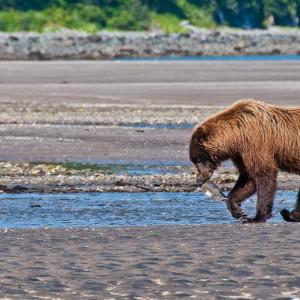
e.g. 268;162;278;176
226;174;255;219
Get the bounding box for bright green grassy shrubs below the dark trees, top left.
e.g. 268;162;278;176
0;0;215;33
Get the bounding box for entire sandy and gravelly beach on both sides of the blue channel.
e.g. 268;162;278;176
0;61;300;300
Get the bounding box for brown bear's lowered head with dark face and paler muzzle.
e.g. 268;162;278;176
189;125;218;186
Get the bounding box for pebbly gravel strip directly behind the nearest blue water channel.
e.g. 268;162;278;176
0;162;299;193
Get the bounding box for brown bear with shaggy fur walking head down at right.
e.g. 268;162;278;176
189;99;300;222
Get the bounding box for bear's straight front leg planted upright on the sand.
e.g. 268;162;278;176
247;169;277;223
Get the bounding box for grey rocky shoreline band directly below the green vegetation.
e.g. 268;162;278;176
0;29;300;60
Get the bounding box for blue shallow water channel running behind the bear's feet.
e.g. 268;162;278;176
0;191;296;228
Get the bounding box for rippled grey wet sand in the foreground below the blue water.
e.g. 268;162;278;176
0;224;300;300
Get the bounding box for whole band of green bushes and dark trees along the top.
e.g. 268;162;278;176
0;0;300;32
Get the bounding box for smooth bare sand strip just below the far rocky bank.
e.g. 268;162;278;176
0;61;300;106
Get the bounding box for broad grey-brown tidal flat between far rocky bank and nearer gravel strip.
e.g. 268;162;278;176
0;61;300;161
